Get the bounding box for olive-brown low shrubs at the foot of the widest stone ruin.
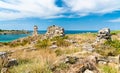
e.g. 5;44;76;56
35;36;70;48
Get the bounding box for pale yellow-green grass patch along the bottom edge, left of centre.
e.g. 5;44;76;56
9;63;52;73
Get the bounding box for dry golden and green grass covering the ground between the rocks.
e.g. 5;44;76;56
0;31;120;73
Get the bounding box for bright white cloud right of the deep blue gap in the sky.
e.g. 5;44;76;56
64;0;120;16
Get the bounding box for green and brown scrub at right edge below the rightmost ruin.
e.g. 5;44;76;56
96;40;120;56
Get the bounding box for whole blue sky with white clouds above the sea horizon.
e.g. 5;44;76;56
0;0;120;30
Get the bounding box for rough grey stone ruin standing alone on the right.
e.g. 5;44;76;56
96;28;111;42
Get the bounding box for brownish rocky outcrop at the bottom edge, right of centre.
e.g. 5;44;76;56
52;56;99;73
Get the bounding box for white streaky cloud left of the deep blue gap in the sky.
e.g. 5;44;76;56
0;0;63;20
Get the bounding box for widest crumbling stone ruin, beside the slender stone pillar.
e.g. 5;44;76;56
45;25;65;38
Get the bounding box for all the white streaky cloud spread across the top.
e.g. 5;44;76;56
0;0;120;20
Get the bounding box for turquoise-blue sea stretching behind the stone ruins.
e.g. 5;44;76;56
0;30;97;42
